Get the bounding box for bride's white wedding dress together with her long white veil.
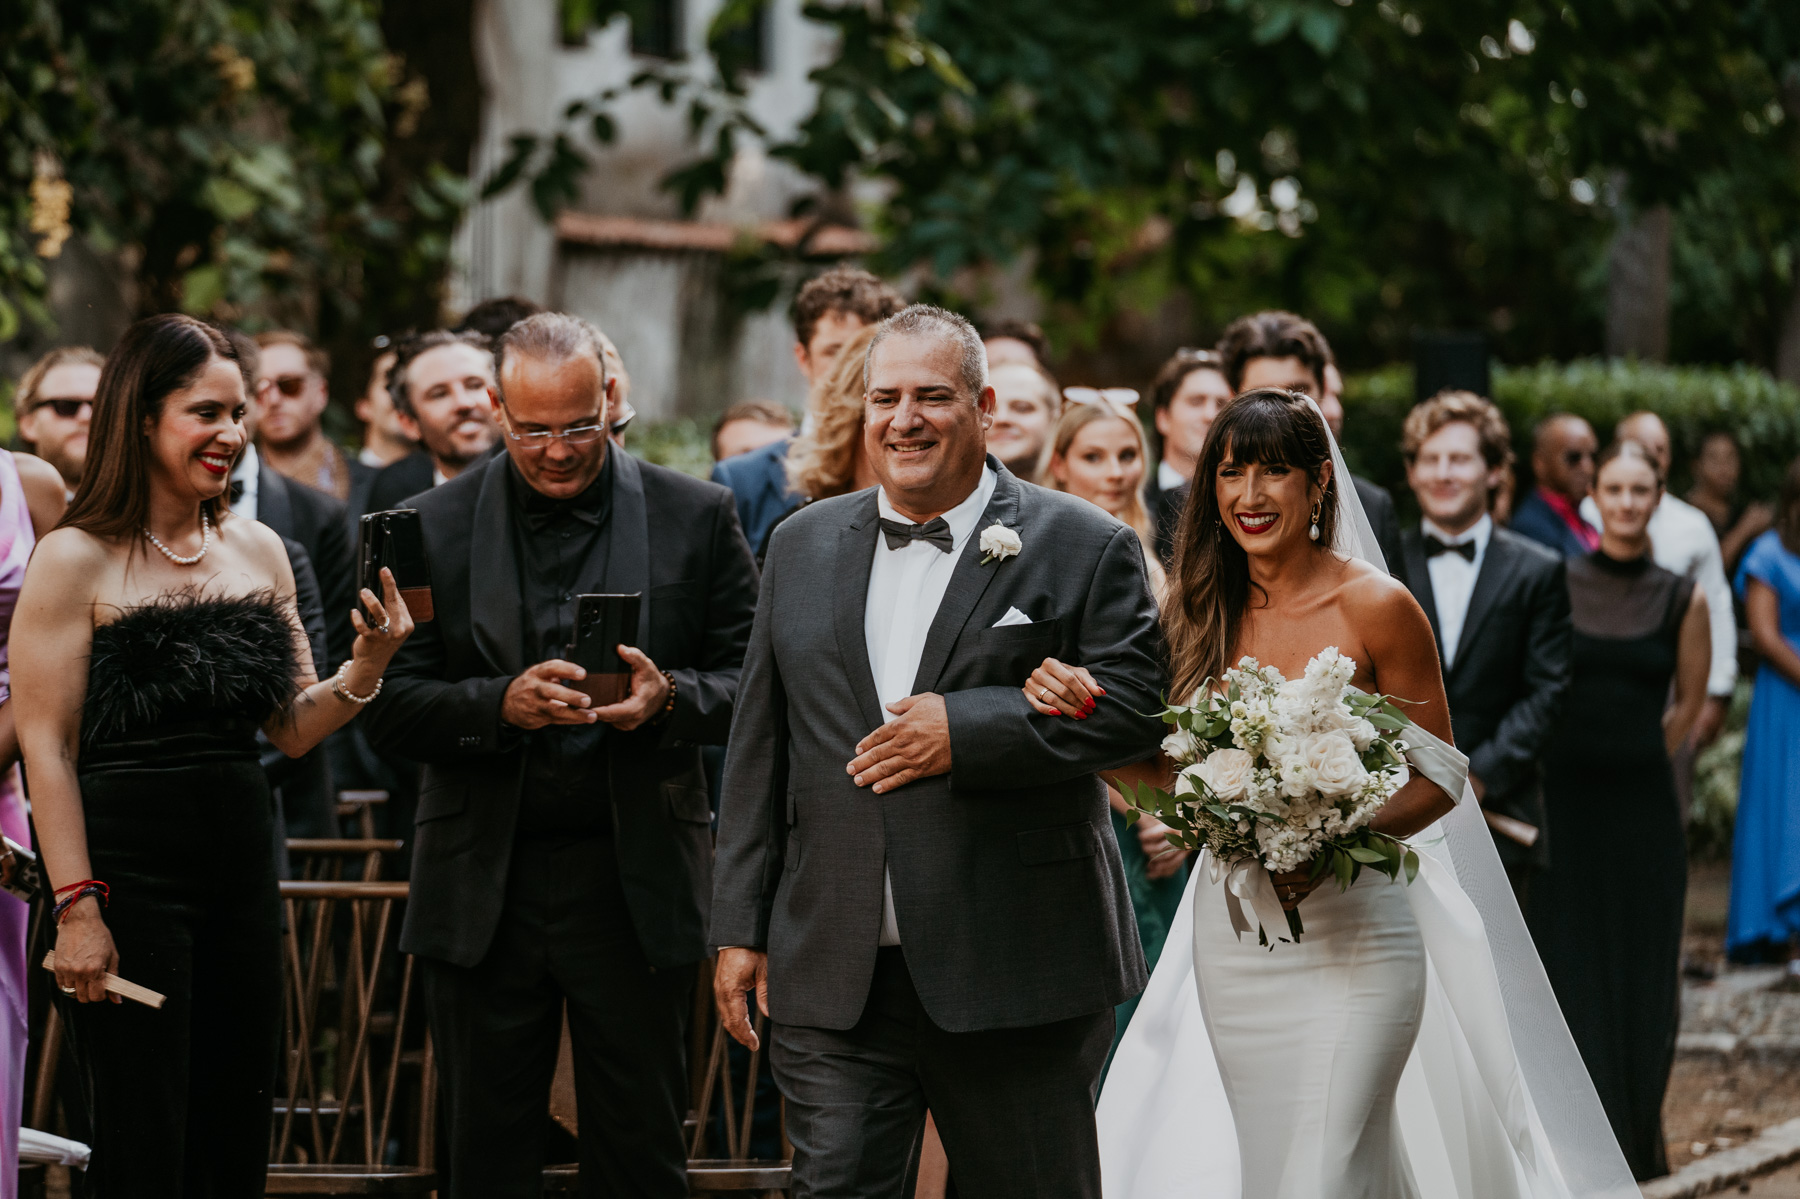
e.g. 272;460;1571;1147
1098;406;1640;1199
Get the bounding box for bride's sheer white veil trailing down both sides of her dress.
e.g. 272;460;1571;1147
1098;405;1640;1199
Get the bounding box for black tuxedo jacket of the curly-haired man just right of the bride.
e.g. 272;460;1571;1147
1400;526;1573;866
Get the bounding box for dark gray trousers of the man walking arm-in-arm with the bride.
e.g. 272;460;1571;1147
770;949;1112;1199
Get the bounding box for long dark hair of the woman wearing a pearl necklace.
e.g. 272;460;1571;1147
56;313;243;538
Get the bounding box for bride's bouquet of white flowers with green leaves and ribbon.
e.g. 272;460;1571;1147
1130;646;1418;943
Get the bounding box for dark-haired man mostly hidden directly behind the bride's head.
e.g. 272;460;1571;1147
1219;311;1406;581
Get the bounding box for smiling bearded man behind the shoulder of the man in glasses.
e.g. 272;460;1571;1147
364;329;499;511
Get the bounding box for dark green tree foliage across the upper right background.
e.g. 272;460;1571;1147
532;0;1800;362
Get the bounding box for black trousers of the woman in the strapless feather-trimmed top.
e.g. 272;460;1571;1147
56;727;281;1199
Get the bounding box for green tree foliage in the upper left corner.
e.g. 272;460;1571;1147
0;0;466;369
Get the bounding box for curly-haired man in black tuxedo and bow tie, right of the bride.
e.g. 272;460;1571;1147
1400;391;1573;906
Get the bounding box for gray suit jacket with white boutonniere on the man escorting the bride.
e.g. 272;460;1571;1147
711;457;1163;1032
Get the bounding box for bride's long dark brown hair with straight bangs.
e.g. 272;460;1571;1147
1163;387;1339;704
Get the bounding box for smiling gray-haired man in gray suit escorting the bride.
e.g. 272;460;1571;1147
711;306;1163;1199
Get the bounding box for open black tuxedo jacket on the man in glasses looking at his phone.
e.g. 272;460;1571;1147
364;446;756;967
